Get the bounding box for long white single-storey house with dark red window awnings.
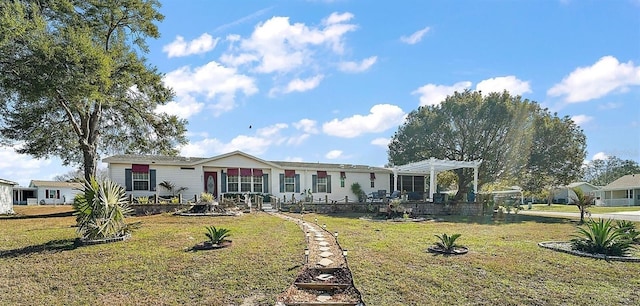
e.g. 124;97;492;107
103;151;392;202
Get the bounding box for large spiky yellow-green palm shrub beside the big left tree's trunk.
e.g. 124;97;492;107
73;177;135;240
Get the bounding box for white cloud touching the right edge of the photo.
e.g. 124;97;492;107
547;56;640;103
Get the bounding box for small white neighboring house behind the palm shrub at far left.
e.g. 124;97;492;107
25;180;82;205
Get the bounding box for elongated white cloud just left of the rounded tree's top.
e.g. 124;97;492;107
322;104;406;138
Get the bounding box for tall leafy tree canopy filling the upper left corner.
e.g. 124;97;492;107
0;0;186;179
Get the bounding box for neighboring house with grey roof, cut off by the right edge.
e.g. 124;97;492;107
596;173;640;206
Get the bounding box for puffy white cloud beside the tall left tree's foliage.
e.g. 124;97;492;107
164;61;258;116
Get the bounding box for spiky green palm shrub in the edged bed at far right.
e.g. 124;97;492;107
571;219;633;256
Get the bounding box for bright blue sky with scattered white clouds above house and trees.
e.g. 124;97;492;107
0;0;640;185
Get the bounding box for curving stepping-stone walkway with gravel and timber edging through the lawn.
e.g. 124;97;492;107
270;212;364;306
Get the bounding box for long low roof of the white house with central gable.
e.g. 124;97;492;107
102;151;391;173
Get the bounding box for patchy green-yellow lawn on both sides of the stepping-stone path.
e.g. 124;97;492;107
0;207;640;305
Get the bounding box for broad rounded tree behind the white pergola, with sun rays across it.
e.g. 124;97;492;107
389;90;585;199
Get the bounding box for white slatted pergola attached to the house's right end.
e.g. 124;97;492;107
391;157;482;200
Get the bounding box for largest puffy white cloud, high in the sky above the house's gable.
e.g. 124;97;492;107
221;13;356;73
